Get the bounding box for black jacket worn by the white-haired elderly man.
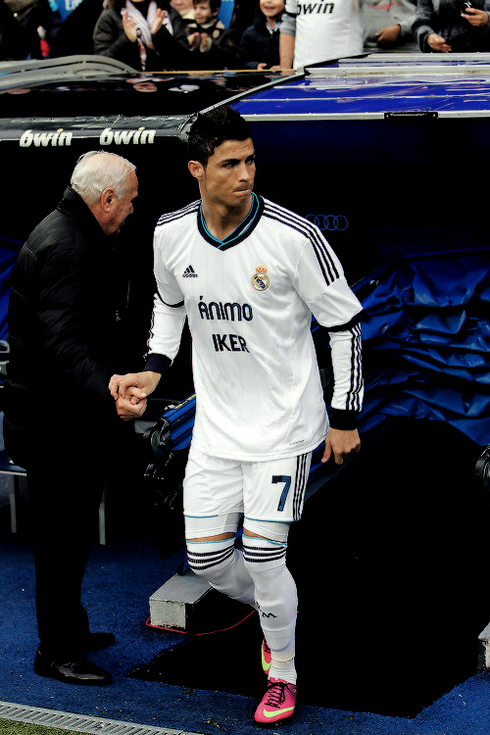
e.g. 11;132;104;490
3;187;132;467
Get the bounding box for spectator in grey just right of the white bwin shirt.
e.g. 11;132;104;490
364;0;418;53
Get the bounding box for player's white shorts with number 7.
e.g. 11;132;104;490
184;445;311;523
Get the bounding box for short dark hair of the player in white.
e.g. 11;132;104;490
187;105;252;166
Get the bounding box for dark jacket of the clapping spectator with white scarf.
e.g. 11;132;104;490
94;3;191;71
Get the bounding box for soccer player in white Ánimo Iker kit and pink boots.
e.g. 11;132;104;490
109;106;363;723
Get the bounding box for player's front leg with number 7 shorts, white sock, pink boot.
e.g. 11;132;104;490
243;454;311;722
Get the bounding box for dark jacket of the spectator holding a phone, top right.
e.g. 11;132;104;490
412;0;490;53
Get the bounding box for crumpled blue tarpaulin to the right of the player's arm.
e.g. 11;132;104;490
355;249;490;446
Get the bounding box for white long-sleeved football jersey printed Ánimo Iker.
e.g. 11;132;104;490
149;194;362;461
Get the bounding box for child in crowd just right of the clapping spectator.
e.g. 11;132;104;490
187;0;226;70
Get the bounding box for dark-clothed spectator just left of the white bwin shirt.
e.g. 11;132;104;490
235;0;284;69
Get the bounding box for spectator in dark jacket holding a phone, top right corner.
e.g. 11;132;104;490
412;0;490;53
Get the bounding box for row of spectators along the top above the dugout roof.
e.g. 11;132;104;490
0;0;490;71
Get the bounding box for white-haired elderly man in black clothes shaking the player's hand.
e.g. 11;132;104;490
4;152;145;685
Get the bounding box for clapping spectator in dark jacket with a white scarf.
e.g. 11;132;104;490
94;0;189;71
